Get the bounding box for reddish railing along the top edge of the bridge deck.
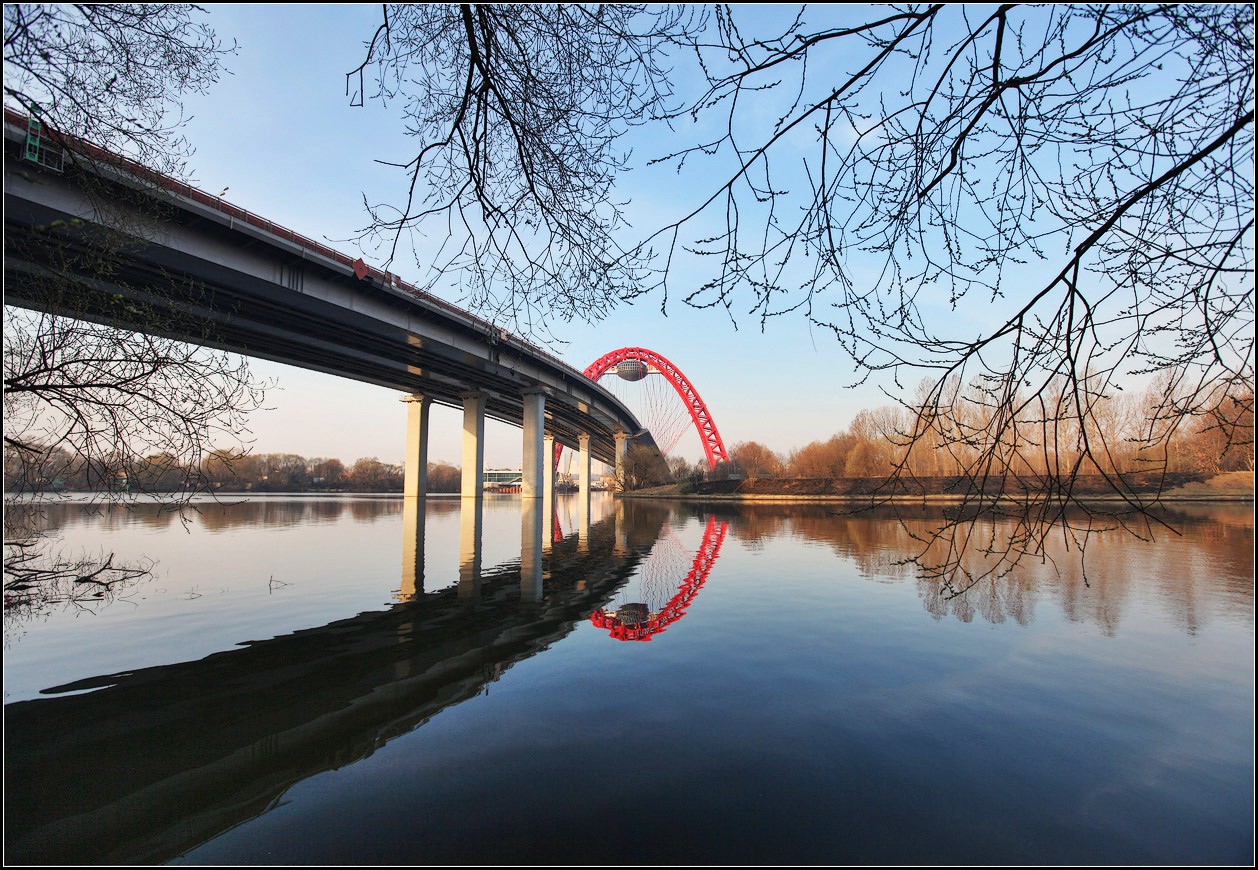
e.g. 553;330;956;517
4;106;585;380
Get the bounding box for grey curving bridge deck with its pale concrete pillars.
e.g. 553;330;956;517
4;109;653;499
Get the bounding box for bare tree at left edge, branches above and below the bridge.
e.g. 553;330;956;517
4;4;264;608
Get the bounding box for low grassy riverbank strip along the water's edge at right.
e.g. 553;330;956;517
620;471;1254;503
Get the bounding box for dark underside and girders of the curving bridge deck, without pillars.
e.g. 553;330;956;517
4;162;649;464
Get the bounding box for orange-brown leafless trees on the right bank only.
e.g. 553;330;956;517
724;380;1254;478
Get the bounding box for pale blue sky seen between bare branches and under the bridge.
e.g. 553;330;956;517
12;5;1237;468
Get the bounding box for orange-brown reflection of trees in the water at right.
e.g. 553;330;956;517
712;504;1254;635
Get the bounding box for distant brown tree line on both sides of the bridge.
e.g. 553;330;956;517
4;381;1254;493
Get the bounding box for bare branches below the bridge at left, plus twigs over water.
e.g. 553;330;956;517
4;274;264;612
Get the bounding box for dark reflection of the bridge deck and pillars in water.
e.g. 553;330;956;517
5;499;726;864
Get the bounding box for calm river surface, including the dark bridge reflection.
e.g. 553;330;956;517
4;497;1254;865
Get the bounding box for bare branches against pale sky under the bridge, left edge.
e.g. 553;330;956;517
4;302;262;499
